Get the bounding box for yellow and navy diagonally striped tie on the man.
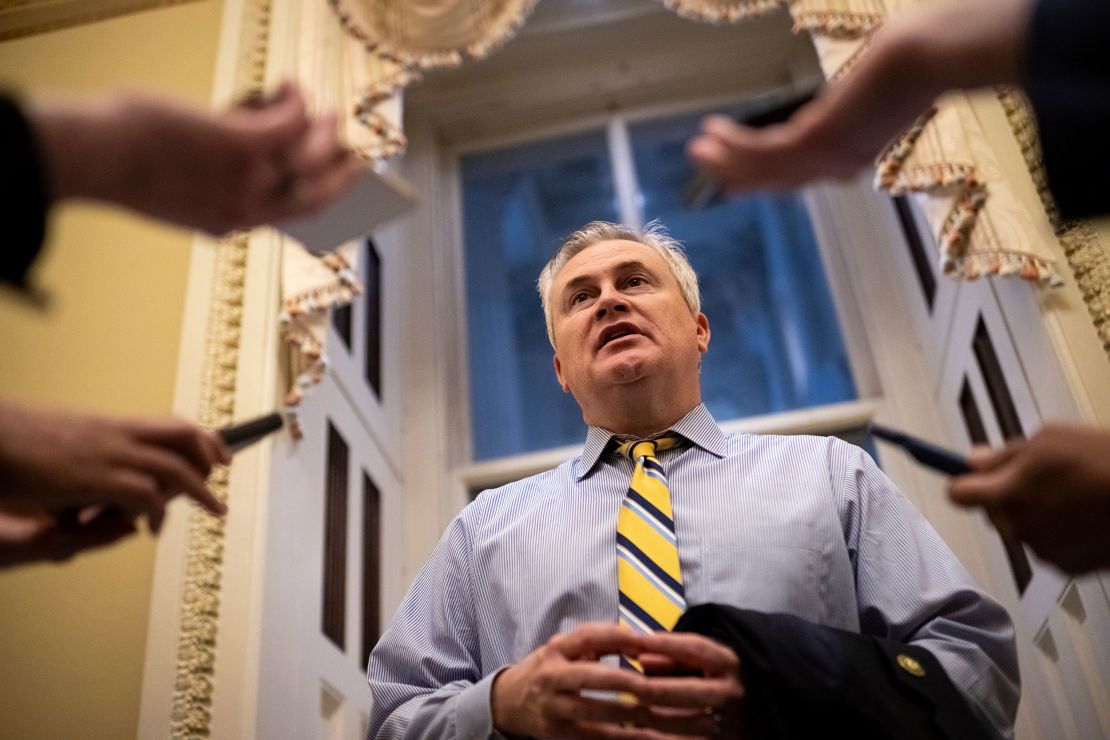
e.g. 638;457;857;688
617;435;686;670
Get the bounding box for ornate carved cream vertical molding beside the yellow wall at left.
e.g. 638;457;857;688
170;0;270;740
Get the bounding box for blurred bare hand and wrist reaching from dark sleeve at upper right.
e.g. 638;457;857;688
686;0;1031;192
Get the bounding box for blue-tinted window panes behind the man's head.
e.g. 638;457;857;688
461;105;857;460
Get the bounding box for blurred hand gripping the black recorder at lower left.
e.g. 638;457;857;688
0;403;231;531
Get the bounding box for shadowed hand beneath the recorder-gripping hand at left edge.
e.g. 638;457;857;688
0;508;135;568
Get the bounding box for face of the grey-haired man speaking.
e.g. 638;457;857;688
551;241;709;405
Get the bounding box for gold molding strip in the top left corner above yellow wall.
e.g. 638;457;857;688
0;0;207;41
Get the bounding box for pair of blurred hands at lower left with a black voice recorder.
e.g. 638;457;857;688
0;403;282;567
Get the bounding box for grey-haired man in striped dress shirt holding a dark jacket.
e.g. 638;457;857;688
367;222;1018;739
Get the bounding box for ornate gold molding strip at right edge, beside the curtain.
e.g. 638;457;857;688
998;88;1110;359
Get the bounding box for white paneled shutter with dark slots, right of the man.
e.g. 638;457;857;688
938;282;1110;740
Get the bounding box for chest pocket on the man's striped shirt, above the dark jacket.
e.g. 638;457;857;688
699;523;825;622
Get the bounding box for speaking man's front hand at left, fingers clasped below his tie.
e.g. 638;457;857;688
491;624;713;740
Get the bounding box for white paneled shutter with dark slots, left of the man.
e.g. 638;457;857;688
254;236;404;740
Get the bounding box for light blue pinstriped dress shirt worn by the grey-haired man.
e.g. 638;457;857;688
367;405;1019;740
